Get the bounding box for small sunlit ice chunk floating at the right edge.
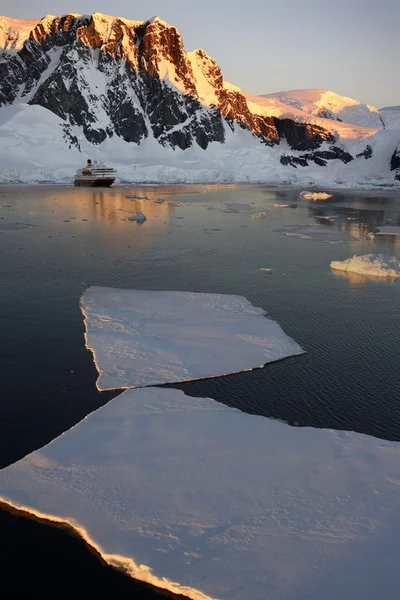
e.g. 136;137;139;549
331;254;400;277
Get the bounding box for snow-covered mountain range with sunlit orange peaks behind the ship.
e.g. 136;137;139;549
0;13;400;181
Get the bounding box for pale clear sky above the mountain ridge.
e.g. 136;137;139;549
0;0;400;108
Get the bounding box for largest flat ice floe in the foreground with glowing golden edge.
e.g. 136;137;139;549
0;388;400;600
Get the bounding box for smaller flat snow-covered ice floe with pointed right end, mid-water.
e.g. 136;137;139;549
81;287;303;390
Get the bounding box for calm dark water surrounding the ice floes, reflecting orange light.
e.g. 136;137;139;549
0;186;400;597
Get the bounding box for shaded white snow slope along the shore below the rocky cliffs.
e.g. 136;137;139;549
0;104;397;187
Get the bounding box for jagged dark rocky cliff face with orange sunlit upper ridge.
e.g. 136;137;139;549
0;13;368;166
